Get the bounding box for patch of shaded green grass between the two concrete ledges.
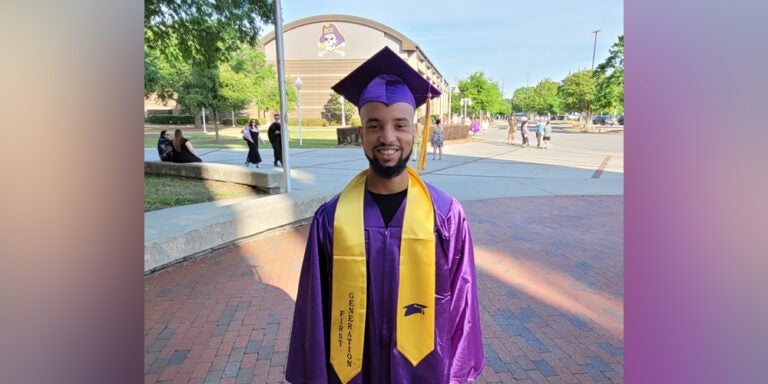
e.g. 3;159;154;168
144;175;263;212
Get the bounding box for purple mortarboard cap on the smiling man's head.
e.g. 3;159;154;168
331;47;440;109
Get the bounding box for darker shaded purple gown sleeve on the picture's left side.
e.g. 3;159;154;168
285;204;332;383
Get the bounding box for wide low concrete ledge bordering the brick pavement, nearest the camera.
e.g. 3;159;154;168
144;191;336;274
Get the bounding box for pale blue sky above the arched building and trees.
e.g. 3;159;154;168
264;0;624;97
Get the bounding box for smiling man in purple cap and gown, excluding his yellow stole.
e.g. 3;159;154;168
285;48;485;383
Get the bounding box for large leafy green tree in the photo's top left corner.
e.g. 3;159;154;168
144;0;280;141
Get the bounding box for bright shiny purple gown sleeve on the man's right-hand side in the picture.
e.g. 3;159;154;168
449;200;485;383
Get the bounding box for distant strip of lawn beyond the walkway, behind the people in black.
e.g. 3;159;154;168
144;125;354;149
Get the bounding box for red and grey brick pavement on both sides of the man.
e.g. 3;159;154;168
144;196;624;383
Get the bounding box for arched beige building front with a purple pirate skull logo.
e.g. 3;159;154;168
261;15;451;118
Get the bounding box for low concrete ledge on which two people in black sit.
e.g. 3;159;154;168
144;161;282;194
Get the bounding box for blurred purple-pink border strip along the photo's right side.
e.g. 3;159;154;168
624;0;768;383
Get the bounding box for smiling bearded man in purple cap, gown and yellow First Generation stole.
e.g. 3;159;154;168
285;48;485;383
